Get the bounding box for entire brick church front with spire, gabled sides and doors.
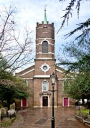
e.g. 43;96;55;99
16;10;72;107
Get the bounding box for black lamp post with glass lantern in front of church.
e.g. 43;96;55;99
50;72;56;128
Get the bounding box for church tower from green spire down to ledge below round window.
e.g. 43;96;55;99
35;9;55;75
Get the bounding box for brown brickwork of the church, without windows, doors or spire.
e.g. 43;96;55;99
16;23;73;107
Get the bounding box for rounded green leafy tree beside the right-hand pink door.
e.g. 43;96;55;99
64;73;90;103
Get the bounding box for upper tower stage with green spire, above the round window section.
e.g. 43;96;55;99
36;10;55;59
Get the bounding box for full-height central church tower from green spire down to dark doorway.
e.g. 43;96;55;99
34;9;56;107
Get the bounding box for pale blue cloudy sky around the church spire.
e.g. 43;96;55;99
0;0;90;70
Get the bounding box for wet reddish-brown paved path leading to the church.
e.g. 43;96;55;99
17;108;88;128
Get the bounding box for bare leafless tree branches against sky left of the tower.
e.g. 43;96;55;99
0;7;33;70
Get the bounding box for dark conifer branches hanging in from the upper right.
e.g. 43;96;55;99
59;0;90;71
